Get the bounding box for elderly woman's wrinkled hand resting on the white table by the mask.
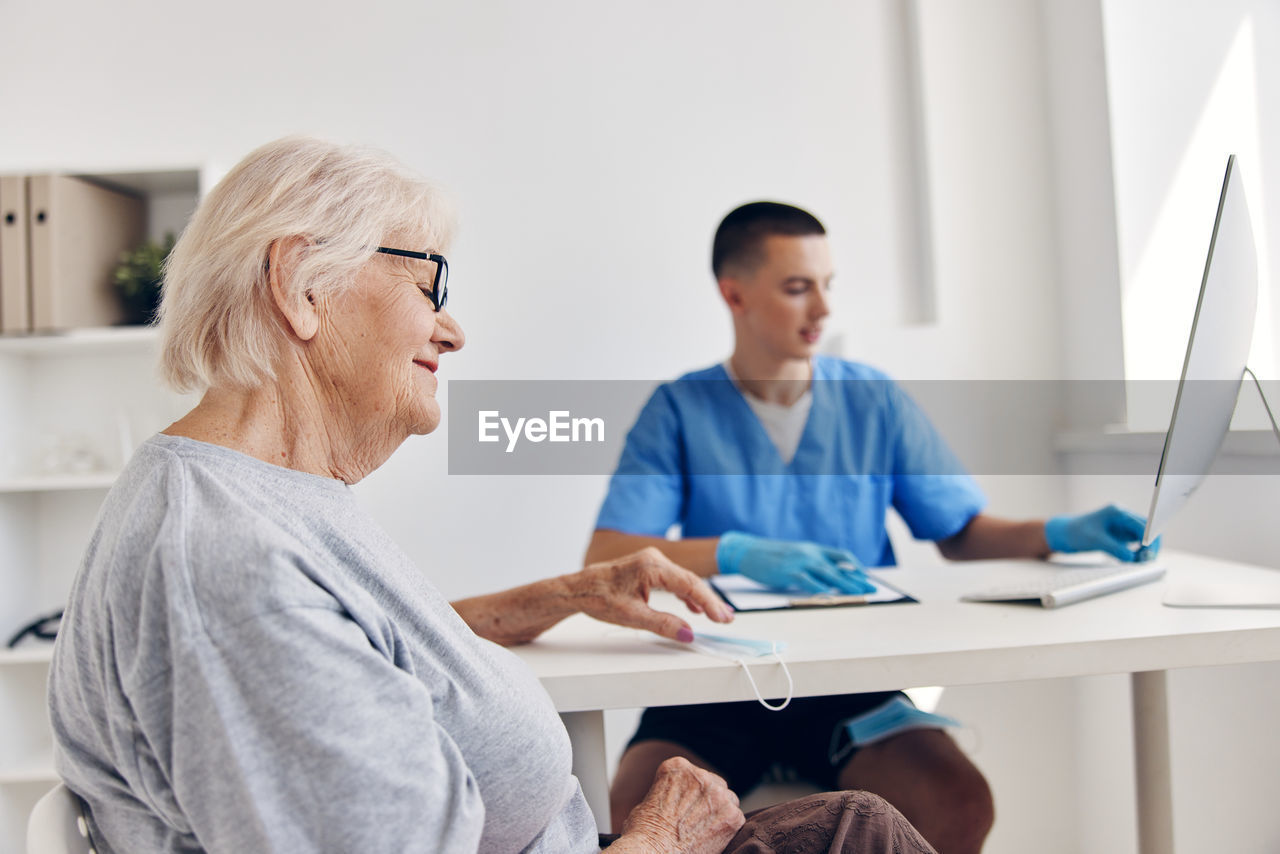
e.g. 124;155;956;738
566;547;733;643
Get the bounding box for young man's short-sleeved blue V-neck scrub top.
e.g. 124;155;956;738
595;356;987;566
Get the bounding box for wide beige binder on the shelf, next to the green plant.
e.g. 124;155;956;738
27;174;146;332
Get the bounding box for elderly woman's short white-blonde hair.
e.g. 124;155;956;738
157;137;454;392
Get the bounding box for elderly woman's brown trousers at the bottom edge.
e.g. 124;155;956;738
600;791;936;854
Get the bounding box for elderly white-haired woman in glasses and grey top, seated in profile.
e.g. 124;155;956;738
50;138;928;854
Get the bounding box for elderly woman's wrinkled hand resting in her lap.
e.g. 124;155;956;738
609;757;746;854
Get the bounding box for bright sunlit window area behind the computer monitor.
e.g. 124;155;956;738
1103;0;1280;419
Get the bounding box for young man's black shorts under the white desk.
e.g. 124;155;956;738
627;691;902;796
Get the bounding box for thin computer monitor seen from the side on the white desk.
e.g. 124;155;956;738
1142;155;1258;545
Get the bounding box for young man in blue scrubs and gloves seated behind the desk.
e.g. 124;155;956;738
586;202;1143;854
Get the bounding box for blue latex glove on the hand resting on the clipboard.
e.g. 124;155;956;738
716;531;876;594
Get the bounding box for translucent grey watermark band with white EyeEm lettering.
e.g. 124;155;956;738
443;378;1280;478
